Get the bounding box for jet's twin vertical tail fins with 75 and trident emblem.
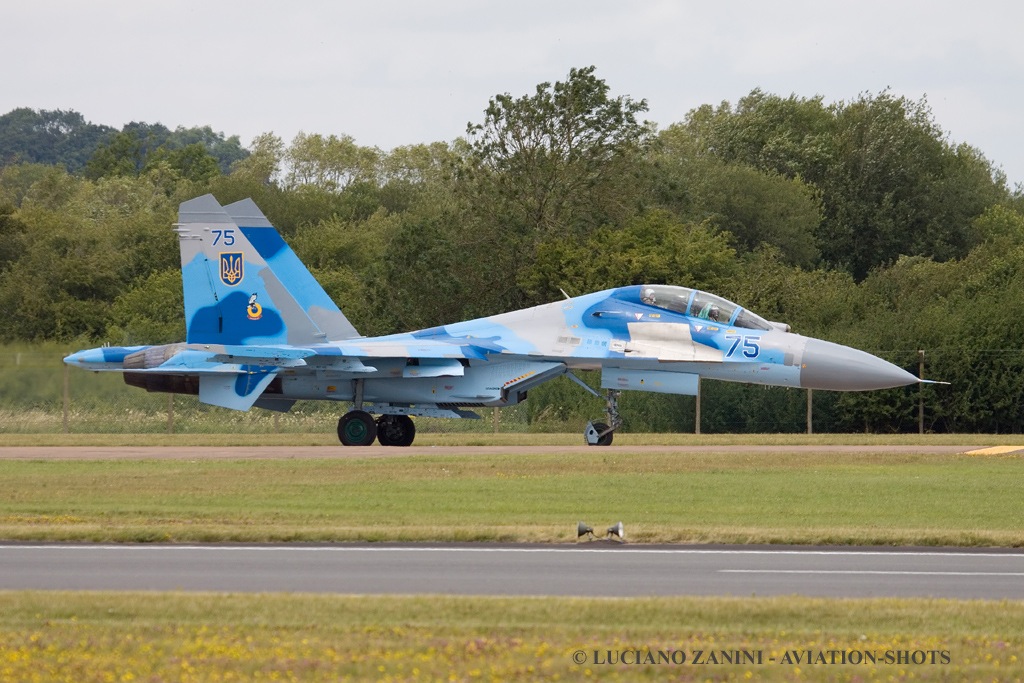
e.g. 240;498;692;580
174;195;359;345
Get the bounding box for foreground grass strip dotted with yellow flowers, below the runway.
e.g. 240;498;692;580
0;592;1024;683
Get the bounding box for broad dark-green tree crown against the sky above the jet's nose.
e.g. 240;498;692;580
686;90;1008;280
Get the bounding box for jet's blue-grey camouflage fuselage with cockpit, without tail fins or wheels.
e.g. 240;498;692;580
69;286;918;407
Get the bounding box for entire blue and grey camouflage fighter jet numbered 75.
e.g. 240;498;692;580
65;195;919;446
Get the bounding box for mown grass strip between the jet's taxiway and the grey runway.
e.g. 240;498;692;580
0;449;1024;546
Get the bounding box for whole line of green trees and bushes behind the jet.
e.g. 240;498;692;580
0;67;1024;432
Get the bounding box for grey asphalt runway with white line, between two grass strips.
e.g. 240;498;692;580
0;541;1024;600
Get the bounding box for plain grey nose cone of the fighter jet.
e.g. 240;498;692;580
800;339;918;391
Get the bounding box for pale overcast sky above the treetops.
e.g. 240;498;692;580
8;0;1024;185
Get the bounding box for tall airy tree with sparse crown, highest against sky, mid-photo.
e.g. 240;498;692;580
466;67;651;243
